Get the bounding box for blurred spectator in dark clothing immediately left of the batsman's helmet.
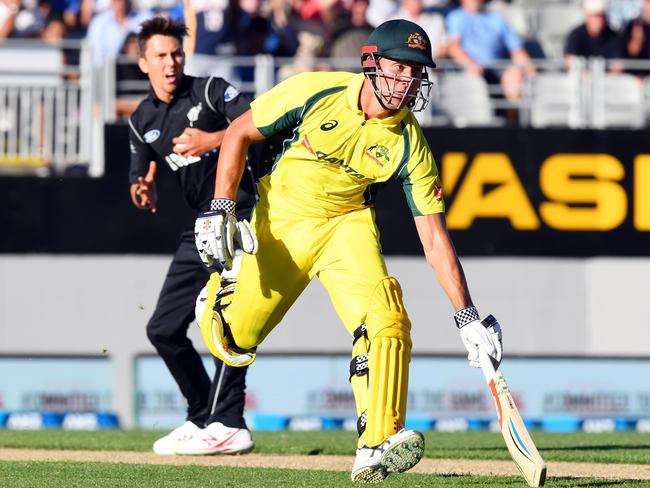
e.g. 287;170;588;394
325;0;374;59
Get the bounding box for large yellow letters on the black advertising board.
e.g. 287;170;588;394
441;152;650;231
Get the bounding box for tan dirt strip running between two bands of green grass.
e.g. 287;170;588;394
0;449;650;480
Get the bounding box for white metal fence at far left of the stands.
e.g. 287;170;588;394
0;41;103;176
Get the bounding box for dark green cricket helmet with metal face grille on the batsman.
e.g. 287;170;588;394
361;19;436;112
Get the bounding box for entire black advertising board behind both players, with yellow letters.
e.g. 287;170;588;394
0;125;650;256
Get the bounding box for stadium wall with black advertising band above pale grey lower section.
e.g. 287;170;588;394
0;125;650;426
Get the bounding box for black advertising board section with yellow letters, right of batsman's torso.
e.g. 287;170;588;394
377;128;650;256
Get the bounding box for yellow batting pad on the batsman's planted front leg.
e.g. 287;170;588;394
364;277;411;446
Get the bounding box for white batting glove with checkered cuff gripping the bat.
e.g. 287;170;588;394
454;307;503;370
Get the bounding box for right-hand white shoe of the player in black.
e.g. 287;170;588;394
176;422;255;456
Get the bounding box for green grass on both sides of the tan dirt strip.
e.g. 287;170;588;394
0;429;650;488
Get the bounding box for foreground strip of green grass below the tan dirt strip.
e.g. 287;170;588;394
0;462;650;488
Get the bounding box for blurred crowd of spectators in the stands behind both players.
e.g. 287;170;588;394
0;0;650;124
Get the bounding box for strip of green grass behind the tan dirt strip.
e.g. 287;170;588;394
0;429;650;466
